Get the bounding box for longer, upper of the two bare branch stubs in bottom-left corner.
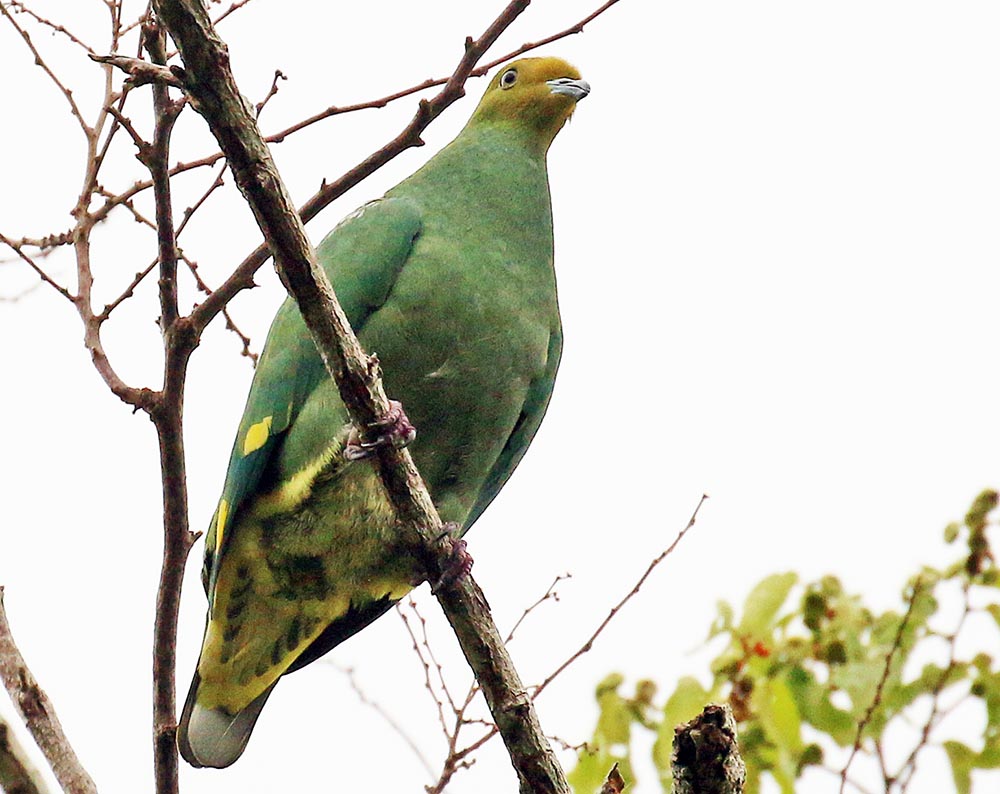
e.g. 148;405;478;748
0;587;97;794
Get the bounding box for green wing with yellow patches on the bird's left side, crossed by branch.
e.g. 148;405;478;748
202;198;421;598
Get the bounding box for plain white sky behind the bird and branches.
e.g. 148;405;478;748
0;0;1000;793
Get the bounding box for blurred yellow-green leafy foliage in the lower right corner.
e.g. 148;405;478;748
570;491;1000;794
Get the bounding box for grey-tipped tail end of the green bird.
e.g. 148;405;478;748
177;672;277;769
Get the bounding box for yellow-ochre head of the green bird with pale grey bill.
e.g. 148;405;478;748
470;58;590;149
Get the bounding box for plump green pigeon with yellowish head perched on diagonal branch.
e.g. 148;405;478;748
177;58;590;767
